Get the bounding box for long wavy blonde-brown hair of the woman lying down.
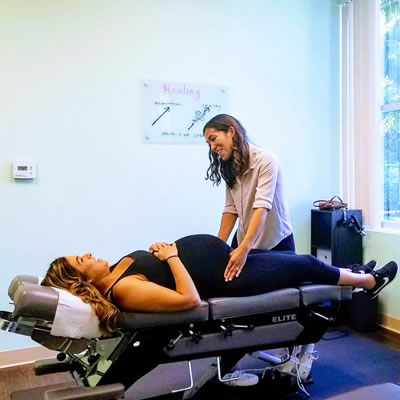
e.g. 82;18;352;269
41;257;120;336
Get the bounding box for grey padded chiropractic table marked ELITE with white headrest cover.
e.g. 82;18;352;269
0;275;352;400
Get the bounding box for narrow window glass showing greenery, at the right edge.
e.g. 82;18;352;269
381;0;400;222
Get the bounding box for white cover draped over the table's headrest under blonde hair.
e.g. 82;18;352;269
50;288;101;339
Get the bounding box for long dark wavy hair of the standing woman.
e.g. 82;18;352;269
203;114;249;189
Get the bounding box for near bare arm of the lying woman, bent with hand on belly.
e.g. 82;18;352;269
113;243;201;312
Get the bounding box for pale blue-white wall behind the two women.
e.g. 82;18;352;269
0;0;339;350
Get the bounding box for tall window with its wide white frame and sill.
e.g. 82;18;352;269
340;0;400;232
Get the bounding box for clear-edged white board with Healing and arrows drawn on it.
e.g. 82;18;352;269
141;80;227;144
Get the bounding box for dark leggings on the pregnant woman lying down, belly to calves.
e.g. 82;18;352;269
176;235;340;298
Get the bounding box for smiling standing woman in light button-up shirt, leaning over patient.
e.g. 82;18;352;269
203;114;295;280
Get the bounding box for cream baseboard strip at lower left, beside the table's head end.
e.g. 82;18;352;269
0;346;58;368
